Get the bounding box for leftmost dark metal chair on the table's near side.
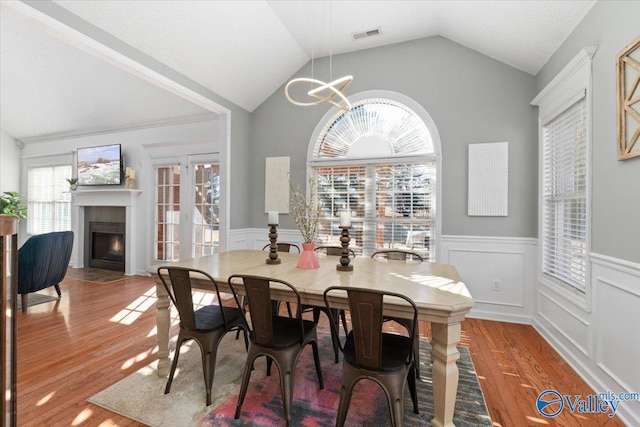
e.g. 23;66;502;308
158;267;248;406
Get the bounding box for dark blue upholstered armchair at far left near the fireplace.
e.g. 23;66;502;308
18;231;73;313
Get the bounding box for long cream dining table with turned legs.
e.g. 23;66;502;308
149;249;474;427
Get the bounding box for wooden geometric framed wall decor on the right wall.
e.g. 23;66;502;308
616;37;640;160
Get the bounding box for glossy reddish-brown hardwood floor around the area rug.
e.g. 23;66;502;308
18;277;624;427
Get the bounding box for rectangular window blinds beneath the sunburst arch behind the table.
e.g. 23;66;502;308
315;162;436;260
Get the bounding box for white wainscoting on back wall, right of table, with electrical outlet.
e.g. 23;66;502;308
438;236;537;324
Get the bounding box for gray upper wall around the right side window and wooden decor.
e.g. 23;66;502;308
536;1;640;263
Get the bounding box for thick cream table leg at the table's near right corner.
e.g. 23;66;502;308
431;322;461;427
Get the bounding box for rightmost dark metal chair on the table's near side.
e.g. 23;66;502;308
324;286;419;427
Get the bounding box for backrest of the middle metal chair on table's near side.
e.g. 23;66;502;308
227;274;304;348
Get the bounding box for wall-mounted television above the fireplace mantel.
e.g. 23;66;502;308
78;144;123;185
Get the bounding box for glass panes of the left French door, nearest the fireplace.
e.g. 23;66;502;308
155;165;180;261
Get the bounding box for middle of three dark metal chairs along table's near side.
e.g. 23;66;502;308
227;275;324;426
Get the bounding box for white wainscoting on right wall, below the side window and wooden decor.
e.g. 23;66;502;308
533;253;640;426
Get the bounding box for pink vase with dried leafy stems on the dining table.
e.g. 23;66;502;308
289;178;322;268
